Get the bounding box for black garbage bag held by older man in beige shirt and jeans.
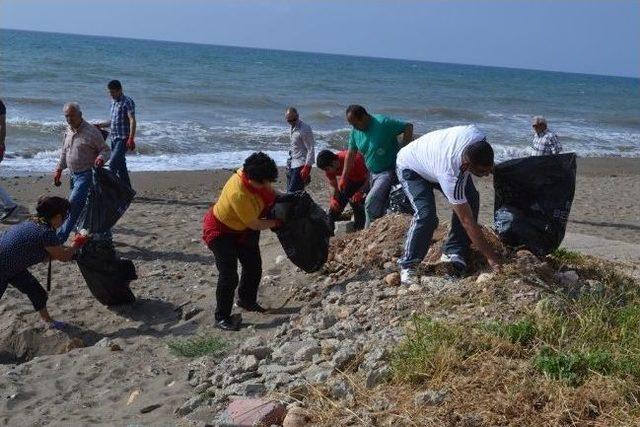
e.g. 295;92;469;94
77;168;136;234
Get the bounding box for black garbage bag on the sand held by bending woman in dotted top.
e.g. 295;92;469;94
76;239;138;306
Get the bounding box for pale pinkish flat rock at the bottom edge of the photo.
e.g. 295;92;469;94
223;399;287;427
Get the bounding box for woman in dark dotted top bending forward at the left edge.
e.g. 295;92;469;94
0;197;87;329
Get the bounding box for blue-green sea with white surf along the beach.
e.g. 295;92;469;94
0;30;640;176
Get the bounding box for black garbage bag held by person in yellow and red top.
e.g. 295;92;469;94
273;192;333;273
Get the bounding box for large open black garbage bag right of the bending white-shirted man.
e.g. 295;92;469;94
493;153;576;256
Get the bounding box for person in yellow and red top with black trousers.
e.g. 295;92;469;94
202;153;280;331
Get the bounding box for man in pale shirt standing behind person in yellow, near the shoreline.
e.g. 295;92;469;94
284;107;316;193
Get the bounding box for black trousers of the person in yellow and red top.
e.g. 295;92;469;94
209;231;262;320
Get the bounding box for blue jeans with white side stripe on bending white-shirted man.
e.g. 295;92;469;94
398;169;480;268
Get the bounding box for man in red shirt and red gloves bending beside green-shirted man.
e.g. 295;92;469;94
316;150;369;230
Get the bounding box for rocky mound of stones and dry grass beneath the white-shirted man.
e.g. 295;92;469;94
177;215;631;426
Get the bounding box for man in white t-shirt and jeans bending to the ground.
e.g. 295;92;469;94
396;125;500;284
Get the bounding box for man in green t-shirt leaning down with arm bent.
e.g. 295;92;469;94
338;105;413;227
